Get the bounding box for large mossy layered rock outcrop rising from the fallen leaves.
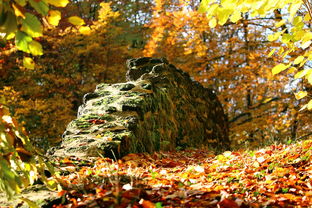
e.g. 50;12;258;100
54;57;230;158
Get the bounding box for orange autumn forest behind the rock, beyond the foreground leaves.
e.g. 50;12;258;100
0;0;312;148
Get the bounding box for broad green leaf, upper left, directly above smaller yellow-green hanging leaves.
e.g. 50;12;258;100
21;13;42;37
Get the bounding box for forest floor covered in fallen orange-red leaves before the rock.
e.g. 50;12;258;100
53;139;312;208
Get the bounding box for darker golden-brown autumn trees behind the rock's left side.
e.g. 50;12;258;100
0;1;155;144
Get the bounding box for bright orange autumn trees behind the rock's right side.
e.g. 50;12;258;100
144;1;308;148
